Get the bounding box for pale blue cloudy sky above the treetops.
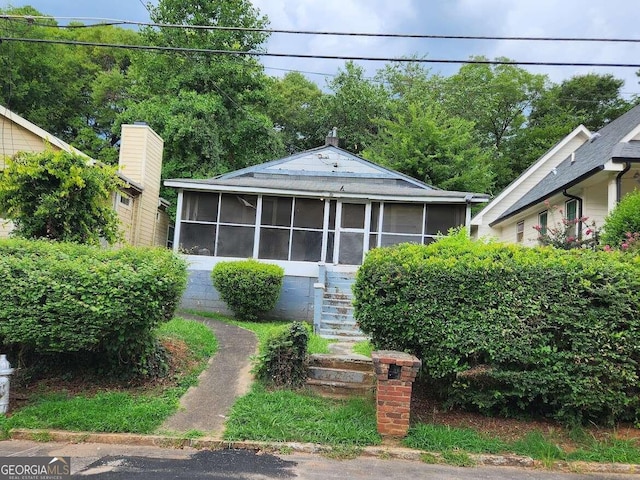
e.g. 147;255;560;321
0;0;640;97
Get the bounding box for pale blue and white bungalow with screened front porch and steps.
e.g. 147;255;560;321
165;133;487;336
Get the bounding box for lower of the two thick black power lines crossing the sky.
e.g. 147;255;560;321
0;37;640;69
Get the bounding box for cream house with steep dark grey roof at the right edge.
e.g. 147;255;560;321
471;101;640;246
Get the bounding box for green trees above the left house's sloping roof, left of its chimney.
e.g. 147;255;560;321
0;7;138;162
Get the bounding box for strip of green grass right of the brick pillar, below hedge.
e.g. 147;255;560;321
404;424;640;467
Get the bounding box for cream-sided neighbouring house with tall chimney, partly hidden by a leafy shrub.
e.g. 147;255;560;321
0;106;169;246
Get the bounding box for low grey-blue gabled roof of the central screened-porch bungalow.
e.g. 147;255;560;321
165;145;487;202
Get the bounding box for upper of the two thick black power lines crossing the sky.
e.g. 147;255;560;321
0;14;640;43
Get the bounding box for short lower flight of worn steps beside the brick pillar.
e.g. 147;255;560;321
307;353;375;398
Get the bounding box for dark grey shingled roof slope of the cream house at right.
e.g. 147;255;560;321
491;105;640;225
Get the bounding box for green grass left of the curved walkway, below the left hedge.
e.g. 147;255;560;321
0;318;217;435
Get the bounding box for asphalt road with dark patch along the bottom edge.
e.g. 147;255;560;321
0;440;638;480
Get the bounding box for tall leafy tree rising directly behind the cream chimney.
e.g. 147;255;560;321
124;0;283;182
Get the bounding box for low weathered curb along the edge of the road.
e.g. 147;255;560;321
9;429;640;474
